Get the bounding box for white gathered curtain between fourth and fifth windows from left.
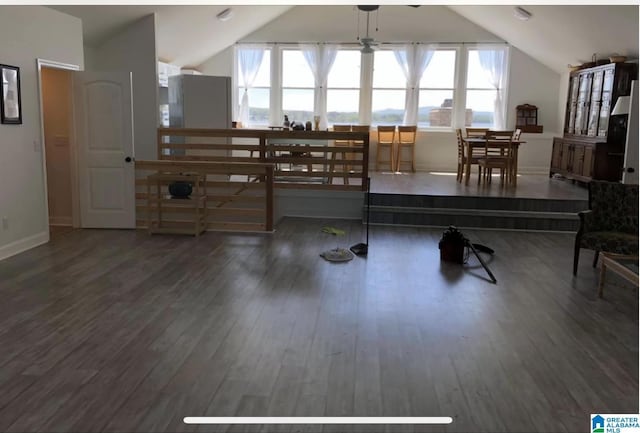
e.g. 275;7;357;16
394;45;435;125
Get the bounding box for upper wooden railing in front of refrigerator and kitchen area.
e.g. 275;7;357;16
157;128;369;191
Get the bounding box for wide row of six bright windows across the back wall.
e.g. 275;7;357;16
235;43;509;129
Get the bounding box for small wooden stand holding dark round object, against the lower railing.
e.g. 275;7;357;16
147;173;207;236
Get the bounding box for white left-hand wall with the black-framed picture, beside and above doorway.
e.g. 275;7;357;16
0;6;84;259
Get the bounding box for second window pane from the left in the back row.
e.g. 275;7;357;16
282;50;315;123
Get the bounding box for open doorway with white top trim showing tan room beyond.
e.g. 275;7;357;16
38;59;80;237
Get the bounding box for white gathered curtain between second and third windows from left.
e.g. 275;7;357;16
301;44;338;130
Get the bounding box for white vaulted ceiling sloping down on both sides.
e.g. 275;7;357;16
51;5;638;72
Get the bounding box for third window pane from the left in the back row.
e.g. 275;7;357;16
327;50;361;125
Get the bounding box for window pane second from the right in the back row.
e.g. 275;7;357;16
418;50;457;128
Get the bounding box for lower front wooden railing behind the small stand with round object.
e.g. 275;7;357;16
135;160;274;233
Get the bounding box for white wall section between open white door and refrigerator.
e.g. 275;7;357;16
89;15;160;159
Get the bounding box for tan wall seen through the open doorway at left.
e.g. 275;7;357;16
42;68;73;226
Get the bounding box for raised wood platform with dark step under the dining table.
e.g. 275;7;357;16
370;172;588;232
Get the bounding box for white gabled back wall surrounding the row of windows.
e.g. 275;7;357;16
199;6;566;173
